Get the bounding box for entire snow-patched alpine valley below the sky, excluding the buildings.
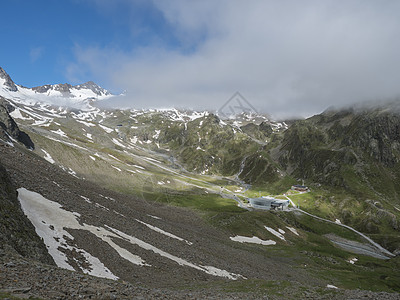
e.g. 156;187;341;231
0;68;400;299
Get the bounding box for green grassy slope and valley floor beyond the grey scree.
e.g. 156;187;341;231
17;107;400;291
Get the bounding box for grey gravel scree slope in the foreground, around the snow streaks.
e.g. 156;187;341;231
0;145;399;299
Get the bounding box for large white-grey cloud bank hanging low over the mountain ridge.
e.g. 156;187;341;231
67;0;400;117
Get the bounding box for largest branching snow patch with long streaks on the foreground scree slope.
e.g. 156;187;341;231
18;188;244;280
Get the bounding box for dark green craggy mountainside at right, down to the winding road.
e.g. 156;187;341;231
262;101;400;253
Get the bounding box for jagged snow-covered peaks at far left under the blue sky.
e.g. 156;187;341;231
0;67;114;109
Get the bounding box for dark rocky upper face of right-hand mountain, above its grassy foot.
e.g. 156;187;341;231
274;106;400;192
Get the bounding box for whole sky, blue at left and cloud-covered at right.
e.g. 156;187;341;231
0;0;400;117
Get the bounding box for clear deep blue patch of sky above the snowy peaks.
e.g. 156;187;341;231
0;0;179;87
